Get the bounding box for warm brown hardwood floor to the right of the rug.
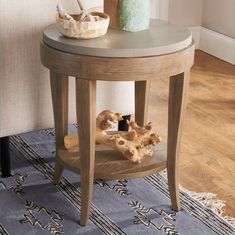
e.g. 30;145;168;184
148;51;235;217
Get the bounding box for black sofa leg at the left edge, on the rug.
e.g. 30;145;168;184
0;136;11;177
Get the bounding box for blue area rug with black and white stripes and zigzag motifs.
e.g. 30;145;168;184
0;126;235;235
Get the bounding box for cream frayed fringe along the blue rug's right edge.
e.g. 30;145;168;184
160;170;235;228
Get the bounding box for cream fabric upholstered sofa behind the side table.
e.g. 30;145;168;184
0;0;134;137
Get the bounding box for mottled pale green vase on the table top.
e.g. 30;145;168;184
119;0;150;32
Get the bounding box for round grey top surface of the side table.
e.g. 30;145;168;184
43;20;192;57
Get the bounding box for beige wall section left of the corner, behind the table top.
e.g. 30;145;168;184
168;0;204;26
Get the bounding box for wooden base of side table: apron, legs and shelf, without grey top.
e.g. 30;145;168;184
41;37;194;225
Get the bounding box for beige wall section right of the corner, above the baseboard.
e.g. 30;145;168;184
202;0;235;38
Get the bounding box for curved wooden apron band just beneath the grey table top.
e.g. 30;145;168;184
41;42;194;81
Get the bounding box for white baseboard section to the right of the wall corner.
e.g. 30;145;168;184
199;27;235;64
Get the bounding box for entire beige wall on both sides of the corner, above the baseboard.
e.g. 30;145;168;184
168;0;235;38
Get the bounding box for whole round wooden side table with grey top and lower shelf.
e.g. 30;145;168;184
41;20;194;225
